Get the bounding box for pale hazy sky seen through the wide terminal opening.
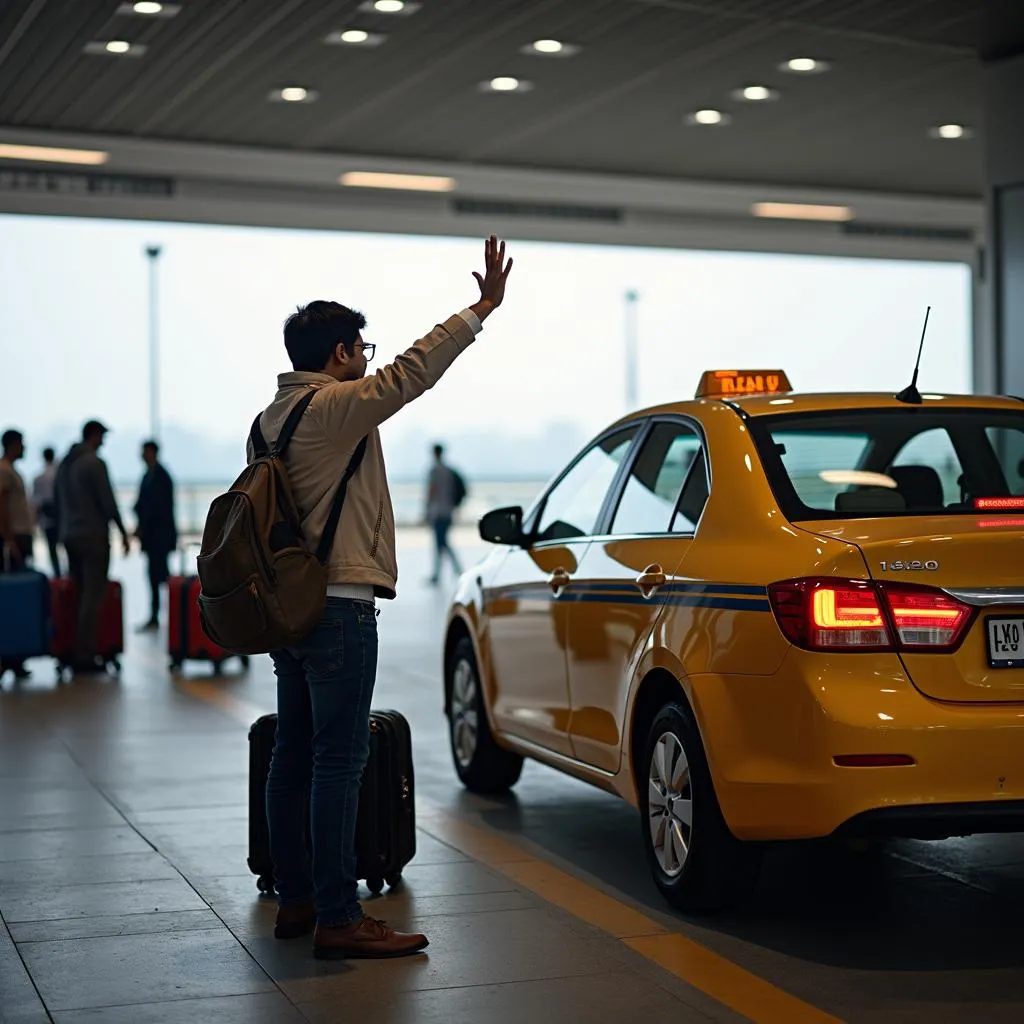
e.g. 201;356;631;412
0;215;971;460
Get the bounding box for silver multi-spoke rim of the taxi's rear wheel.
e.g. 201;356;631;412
647;732;693;879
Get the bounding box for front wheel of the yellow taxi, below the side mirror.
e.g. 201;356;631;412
445;637;522;794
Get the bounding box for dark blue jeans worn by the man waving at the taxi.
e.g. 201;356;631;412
266;597;377;928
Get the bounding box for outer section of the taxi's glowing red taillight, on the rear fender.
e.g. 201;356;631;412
769;580;892;650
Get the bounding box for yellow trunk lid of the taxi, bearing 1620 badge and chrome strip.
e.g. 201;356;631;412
803;515;1024;702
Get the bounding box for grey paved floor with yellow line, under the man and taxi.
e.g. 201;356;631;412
6;534;1024;1024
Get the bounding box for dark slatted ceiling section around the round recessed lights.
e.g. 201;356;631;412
0;0;982;195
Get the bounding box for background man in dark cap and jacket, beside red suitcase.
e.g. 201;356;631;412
56;420;131;674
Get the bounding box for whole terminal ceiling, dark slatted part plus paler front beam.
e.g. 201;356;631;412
0;0;1024;261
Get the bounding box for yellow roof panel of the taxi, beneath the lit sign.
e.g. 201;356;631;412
626;391;1024;419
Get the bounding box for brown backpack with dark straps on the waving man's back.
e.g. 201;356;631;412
197;388;367;654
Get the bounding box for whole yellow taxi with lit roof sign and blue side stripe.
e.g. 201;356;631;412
443;371;1024;910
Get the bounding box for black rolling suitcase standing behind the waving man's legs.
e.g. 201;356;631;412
249;711;416;894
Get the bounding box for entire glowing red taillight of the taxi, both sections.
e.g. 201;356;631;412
768;578;973;651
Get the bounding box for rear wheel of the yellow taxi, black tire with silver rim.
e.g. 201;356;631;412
637;701;761;913
